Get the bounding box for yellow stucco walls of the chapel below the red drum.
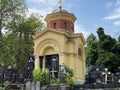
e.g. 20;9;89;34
33;28;85;82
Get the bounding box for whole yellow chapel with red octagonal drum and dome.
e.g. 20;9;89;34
33;2;86;82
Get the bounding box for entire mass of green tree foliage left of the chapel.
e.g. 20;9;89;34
0;0;43;71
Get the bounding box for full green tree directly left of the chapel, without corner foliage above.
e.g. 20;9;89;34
0;14;43;70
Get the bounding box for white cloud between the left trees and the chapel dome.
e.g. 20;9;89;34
28;0;57;17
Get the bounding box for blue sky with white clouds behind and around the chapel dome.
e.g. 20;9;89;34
27;0;120;38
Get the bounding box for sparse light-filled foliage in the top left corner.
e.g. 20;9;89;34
0;0;26;37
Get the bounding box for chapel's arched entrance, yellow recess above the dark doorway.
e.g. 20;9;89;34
39;43;59;78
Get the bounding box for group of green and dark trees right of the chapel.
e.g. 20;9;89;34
86;27;120;73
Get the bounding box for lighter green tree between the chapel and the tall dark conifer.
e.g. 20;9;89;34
86;33;98;65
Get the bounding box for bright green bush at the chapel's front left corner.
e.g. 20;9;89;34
33;69;49;85
